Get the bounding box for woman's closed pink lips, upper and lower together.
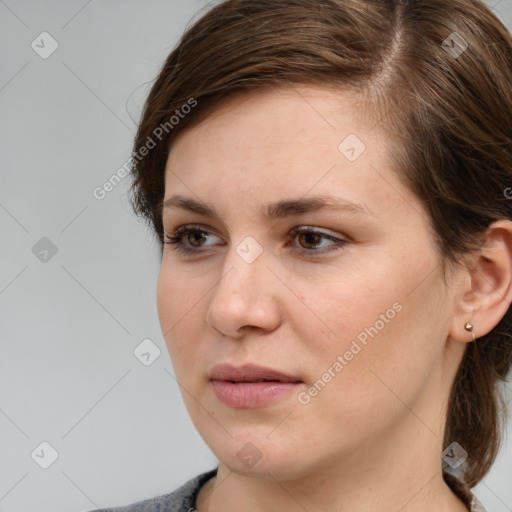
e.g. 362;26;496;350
208;364;302;409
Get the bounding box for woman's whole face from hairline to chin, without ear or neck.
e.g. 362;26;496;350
158;86;462;479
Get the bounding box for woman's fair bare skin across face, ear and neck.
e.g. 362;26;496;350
157;86;512;512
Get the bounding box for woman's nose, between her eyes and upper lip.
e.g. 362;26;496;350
206;247;283;339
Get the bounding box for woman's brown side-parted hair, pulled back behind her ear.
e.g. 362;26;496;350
132;0;512;496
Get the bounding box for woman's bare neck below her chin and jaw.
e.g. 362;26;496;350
196;464;468;512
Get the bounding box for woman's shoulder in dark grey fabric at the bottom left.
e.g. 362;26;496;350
89;468;217;512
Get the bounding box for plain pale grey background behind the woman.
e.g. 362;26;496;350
0;0;512;512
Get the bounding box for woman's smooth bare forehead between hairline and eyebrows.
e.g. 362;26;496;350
165;86;412;222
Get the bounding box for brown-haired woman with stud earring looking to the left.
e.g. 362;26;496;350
90;0;512;512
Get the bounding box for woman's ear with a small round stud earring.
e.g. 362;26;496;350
449;219;512;341
